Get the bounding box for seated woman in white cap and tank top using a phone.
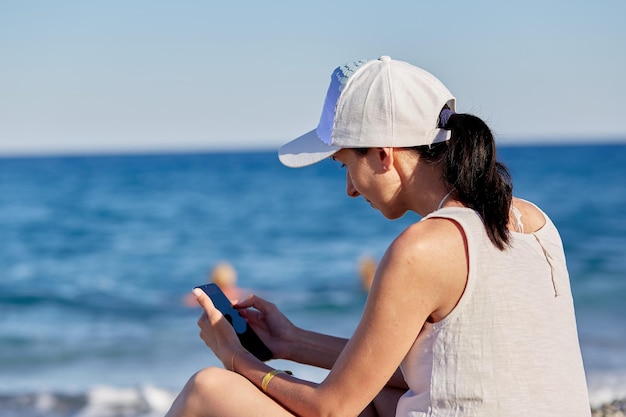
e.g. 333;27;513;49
165;57;590;417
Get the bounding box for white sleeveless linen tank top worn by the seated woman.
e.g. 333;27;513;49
396;207;591;417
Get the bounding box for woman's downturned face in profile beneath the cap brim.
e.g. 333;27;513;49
333;148;406;219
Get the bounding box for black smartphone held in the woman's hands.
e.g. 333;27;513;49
196;284;274;362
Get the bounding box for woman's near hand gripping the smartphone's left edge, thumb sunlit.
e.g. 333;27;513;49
193;288;243;369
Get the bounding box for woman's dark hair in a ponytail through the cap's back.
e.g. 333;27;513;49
413;113;513;250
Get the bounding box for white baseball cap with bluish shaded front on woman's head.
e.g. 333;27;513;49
278;56;456;168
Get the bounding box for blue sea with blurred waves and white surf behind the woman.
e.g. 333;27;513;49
0;141;626;417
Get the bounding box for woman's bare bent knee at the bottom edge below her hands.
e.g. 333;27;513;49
166;368;293;417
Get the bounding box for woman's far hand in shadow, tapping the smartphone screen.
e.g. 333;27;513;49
235;294;298;359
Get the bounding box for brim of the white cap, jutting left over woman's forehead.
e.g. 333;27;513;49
278;129;341;168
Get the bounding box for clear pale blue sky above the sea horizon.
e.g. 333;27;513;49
0;0;626;155
